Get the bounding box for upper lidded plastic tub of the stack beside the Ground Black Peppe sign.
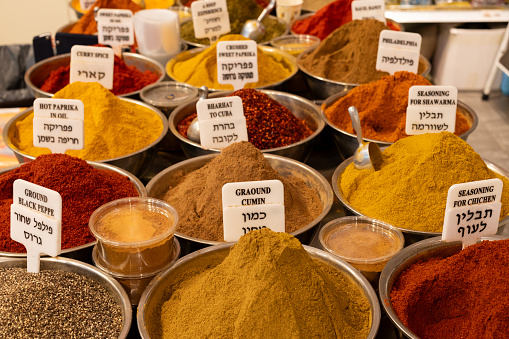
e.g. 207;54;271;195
89;197;178;276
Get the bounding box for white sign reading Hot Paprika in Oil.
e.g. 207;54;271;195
33;98;85;153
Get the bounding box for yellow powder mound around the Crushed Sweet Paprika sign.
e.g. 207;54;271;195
166;34;295;90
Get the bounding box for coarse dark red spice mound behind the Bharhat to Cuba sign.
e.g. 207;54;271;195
177;88;313;150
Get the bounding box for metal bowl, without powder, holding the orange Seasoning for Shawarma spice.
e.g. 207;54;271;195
320;90;479;159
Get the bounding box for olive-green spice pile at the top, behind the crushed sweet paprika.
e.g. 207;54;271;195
180;0;287;45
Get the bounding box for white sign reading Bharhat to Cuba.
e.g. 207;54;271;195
196;96;248;149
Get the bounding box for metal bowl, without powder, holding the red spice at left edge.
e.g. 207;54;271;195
0;161;147;262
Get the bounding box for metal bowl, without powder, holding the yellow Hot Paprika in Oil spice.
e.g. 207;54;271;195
2;98;168;177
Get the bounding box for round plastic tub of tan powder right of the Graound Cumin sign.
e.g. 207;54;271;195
319;216;405;282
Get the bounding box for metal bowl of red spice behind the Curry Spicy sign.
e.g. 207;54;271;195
25;53;166;98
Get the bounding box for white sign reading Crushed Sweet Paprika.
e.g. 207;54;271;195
217;40;258;90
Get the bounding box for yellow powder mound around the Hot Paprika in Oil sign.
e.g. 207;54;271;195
12;82;163;160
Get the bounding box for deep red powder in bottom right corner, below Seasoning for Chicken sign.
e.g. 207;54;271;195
390;240;509;339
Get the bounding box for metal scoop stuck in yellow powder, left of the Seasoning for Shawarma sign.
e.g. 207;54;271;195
348;106;383;171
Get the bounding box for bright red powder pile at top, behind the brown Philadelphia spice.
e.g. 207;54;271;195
292;0;400;40
